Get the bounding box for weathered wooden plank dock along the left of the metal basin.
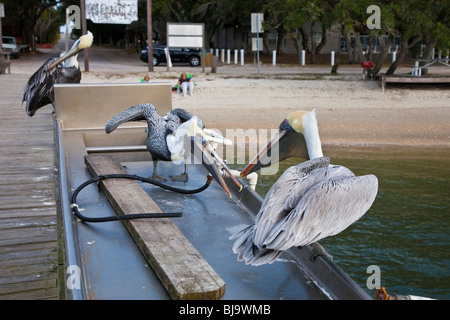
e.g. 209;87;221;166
0;73;60;300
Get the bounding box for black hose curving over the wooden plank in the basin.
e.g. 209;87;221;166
71;173;213;222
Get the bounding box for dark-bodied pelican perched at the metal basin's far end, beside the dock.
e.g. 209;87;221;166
22;31;93;117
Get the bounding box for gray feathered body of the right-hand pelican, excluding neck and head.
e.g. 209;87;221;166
230;157;378;265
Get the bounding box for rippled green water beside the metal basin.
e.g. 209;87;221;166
230;147;450;299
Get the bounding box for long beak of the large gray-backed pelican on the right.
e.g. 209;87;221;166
241;119;309;177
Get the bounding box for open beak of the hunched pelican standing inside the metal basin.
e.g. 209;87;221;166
191;137;242;196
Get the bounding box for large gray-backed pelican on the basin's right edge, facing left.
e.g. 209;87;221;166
231;110;378;265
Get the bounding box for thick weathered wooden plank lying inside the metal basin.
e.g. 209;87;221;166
85;156;225;300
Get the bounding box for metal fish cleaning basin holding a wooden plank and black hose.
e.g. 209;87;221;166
50;83;371;299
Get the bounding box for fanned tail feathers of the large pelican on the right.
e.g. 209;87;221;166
230;225;281;266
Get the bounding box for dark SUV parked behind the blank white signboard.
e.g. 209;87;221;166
140;43;201;67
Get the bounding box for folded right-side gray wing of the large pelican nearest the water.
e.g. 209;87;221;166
263;175;378;250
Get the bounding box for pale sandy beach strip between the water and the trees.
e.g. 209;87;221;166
83;67;450;147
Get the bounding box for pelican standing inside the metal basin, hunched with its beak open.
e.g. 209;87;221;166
105;103;242;194
